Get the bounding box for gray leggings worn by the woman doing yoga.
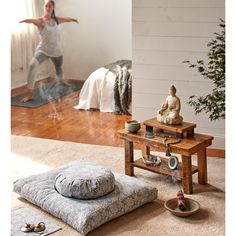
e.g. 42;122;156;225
27;52;63;90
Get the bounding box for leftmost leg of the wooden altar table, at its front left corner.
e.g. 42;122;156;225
125;140;134;176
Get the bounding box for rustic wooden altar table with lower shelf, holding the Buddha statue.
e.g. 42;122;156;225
117;129;213;194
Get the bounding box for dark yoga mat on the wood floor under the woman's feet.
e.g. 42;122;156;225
11;81;83;108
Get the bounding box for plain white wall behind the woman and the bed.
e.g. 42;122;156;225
12;0;132;88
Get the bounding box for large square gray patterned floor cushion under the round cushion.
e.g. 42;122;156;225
14;160;157;235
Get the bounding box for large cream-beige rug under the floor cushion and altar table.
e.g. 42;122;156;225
11;136;225;236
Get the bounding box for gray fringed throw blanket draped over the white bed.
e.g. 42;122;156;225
105;60;132;115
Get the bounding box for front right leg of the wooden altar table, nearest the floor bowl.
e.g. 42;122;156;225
182;155;193;194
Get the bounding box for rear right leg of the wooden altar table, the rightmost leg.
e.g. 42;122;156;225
197;148;207;184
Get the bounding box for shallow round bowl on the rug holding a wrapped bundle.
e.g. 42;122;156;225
164;198;200;217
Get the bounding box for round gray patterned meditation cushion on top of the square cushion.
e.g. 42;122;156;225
55;162;115;199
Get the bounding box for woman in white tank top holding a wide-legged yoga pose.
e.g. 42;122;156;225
19;0;78;102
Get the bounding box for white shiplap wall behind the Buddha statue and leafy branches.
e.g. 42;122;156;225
132;0;225;149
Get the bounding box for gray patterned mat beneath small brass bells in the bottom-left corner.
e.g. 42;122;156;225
11;207;61;236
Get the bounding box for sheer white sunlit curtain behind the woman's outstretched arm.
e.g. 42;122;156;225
11;0;39;71
